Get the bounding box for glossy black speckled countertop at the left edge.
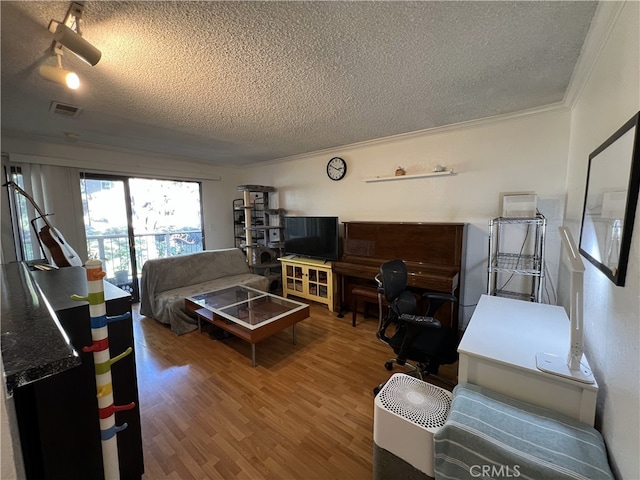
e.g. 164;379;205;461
0;263;82;395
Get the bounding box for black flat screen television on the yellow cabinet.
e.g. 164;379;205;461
284;217;340;260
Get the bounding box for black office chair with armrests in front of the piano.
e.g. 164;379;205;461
374;260;458;393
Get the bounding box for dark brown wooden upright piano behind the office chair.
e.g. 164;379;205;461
333;222;466;326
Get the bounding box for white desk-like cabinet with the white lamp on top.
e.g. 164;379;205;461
458;295;598;425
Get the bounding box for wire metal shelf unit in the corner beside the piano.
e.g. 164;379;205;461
487;214;547;302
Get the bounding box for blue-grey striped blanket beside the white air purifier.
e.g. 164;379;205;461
434;384;613;480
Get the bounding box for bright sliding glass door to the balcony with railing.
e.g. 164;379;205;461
80;174;204;302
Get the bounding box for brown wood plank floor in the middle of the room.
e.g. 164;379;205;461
134;305;456;480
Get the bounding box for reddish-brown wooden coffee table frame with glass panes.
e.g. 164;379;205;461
184;284;309;367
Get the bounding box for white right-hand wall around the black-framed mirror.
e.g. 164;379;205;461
566;2;640;479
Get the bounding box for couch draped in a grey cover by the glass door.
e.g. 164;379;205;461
140;248;269;335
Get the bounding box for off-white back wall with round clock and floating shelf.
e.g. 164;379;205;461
245;109;570;325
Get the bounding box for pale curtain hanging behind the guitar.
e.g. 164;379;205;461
3;159;87;263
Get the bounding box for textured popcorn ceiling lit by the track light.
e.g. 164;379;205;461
0;1;597;165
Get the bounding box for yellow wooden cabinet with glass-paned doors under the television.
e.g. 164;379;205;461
279;256;335;312
